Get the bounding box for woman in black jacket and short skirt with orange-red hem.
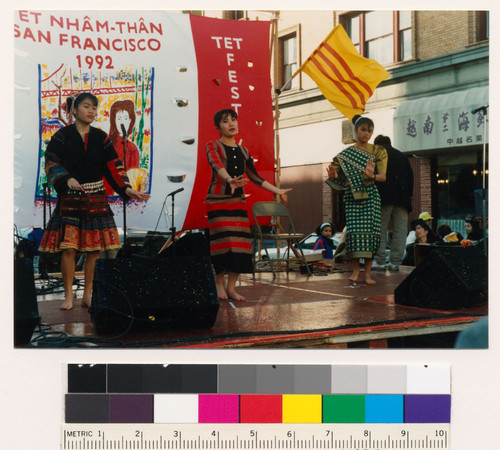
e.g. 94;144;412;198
40;92;149;310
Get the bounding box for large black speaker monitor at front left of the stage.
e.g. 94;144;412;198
90;256;219;333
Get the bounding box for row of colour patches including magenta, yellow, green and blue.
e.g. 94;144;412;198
66;394;451;423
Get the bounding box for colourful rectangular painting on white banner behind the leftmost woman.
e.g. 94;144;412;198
35;64;154;207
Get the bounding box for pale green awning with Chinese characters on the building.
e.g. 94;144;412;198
394;86;489;152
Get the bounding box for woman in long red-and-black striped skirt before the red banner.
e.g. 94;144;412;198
207;109;291;301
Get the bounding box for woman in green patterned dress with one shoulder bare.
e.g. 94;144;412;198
327;115;387;284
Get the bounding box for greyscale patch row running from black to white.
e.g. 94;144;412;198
68;364;451;394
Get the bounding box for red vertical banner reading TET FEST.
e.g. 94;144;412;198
183;15;274;229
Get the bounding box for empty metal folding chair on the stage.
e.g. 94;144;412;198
252;202;312;278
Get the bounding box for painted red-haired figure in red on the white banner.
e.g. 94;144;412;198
106;99;149;195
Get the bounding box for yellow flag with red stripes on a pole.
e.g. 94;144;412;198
293;25;389;119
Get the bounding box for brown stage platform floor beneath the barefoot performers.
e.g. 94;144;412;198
25;265;487;349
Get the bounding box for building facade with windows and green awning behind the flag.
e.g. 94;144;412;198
198;10;489;233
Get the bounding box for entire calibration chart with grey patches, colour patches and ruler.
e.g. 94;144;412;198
61;364;451;450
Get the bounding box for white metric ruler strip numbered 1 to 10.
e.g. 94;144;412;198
61;423;450;450
